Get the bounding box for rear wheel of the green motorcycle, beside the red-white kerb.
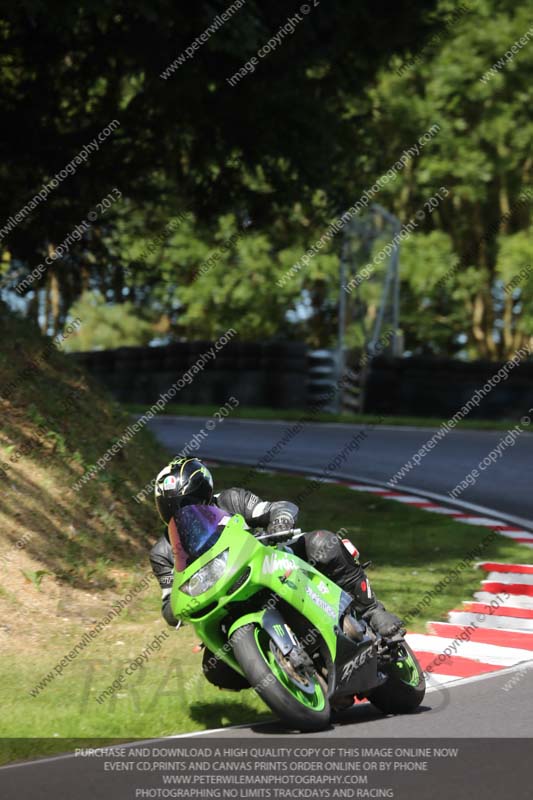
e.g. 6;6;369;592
367;642;426;714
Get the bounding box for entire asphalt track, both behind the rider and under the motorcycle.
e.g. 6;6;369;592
0;417;533;800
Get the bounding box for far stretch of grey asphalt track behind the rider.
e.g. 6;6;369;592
150;416;533;529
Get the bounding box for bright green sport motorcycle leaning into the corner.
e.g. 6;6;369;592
169;505;425;731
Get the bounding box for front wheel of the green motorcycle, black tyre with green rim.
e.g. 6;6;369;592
230;625;331;731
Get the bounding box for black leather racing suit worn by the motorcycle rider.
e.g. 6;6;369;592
150;488;396;690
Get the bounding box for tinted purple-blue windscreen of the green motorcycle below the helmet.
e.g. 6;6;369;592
168;506;224;572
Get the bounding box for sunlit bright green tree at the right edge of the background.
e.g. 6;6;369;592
362;0;533;358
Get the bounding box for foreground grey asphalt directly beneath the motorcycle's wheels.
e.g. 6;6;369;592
0;670;533;800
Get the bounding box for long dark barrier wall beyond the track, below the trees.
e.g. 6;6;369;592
70;341;533;419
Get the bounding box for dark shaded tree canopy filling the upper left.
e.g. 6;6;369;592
0;0;440;332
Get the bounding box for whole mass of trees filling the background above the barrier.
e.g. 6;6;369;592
0;0;533;358
